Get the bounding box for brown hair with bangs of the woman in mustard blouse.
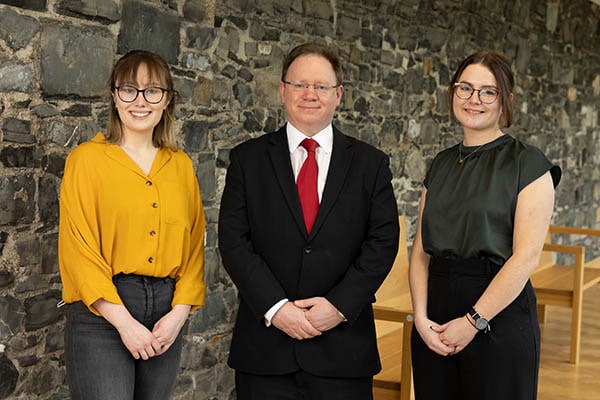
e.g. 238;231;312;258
105;50;177;150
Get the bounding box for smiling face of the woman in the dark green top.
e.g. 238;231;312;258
452;64;502;134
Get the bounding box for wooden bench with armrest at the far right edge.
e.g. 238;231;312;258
531;226;600;364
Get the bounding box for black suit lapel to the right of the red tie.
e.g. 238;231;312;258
310;127;354;238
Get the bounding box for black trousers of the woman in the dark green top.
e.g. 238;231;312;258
411;258;540;400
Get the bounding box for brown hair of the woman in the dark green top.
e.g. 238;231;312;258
448;51;515;128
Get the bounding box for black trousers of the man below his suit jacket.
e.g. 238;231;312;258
235;371;373;400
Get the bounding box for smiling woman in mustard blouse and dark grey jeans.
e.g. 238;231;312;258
59;50;206;400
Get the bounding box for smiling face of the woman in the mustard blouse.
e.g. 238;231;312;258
112;64;170;141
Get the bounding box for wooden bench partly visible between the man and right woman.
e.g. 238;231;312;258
373;215;413;400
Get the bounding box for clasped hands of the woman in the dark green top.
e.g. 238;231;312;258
415;316;478;356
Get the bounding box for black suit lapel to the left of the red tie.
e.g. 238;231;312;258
268;125;304;235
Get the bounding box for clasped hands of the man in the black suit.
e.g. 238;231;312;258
271;297;343;340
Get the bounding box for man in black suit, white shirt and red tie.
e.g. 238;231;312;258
219;43;399;400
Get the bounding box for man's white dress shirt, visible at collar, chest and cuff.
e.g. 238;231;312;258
265;122;333;326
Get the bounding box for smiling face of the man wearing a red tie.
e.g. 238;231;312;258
279;54;343;136
